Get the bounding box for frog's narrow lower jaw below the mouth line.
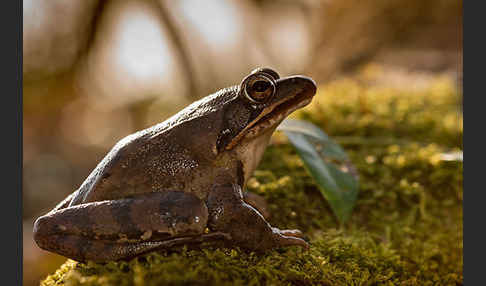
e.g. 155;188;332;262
226;88;314;150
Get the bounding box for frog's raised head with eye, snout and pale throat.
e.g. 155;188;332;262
216;68;316;181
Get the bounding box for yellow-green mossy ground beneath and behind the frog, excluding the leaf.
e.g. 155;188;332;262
41;73;463;286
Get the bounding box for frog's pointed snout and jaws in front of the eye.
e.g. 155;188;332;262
226;76;317;150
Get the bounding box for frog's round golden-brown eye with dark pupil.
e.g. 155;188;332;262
241;73;276;103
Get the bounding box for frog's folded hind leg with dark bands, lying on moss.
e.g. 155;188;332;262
34;191;227;262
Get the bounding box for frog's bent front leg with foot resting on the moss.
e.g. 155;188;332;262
207;184;309;250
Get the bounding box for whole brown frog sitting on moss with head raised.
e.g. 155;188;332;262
33;67;317;262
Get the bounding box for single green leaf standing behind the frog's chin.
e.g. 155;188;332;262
277;119;359;224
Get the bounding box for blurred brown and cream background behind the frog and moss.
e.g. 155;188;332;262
22;0;462;285
